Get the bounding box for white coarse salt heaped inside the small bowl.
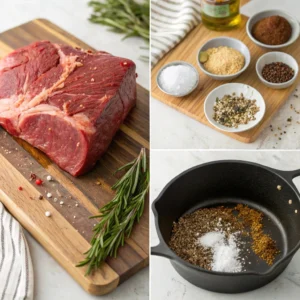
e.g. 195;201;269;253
159;65;198;95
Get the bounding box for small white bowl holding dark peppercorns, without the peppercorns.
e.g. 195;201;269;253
256;52;299;90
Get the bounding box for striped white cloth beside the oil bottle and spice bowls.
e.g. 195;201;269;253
151;0;200;67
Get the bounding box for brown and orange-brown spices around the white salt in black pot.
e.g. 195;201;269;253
169;204;279;270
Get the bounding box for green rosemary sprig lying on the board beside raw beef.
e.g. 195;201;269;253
77;148;149;275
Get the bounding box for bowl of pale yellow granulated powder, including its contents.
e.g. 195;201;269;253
197;37;251;80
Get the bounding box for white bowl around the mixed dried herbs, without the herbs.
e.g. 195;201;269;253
204;83;266;132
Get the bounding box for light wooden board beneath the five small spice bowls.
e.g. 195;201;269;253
151;16;300;143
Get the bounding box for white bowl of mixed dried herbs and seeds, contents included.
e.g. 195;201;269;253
204;83;266;132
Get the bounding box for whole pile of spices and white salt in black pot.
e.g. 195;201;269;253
169;204;279;273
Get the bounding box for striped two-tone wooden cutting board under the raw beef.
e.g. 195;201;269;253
0;19;149;295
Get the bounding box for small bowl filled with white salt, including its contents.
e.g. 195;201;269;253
156;61;199;97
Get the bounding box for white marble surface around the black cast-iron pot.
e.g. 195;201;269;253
150;150;300;300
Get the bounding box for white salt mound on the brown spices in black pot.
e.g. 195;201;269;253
197;232;243;273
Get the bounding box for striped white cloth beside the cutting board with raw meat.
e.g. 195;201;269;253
0;202;33;300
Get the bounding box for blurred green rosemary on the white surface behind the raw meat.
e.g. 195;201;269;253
89;0;150;43
